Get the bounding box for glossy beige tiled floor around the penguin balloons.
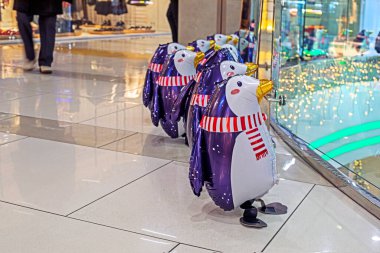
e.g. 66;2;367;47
0;37;380;253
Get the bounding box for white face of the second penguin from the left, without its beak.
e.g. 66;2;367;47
174;50;197;76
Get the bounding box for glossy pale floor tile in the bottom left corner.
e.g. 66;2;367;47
0;203;176;253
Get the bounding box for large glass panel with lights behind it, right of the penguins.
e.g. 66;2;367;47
272;0;380;197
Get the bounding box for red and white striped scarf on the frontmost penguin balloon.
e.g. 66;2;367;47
200;113;269;160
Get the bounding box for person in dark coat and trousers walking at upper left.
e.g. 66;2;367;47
13;0;72;74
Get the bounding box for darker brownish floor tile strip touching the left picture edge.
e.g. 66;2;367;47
0;116;135;147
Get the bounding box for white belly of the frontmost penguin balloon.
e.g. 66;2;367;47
231;126;277;207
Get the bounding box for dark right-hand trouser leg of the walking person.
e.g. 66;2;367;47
38;15;57;67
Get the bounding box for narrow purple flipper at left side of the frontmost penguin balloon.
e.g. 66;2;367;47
189;127;206;197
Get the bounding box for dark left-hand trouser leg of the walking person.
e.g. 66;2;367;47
17;12;36;61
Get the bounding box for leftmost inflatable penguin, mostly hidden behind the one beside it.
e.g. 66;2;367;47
142;43;186;107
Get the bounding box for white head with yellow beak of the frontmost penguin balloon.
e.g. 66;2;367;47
226;75;273;116
